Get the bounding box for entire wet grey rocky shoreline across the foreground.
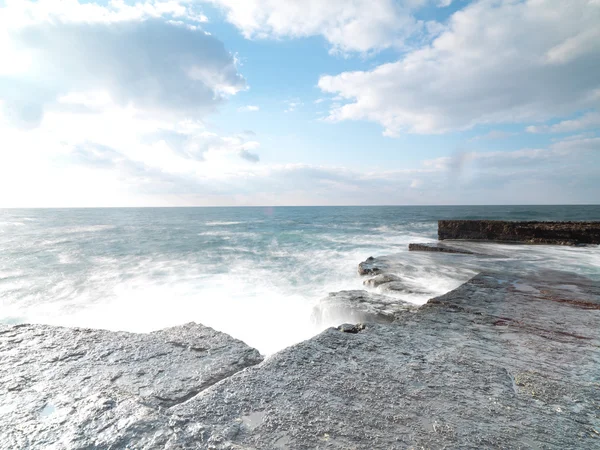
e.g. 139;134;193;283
0;246;600;449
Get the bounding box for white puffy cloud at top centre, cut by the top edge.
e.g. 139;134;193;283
205;0;426;53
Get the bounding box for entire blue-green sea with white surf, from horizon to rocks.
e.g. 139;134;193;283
0;205;600;355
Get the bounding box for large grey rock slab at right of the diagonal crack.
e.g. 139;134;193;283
173;273;600;450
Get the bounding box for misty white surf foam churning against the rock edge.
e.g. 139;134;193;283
0;218;600;354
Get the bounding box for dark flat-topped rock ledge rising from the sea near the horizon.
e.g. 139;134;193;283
438;220;600;245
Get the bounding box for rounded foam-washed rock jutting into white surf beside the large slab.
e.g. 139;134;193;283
313;291;415;325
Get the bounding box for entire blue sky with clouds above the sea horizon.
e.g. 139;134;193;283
0;0;600;207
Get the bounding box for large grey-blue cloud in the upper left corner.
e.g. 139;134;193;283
0;0;246;127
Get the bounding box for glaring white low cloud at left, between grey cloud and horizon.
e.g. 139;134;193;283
0;101;259;207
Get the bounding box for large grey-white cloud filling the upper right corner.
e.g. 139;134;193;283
319;0;600;136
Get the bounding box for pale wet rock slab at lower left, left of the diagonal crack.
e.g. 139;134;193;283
0;323;262;449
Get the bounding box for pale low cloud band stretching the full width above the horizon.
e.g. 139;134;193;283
0;98;600;207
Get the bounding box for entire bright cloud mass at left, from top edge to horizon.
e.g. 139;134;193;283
0;0;260;206
